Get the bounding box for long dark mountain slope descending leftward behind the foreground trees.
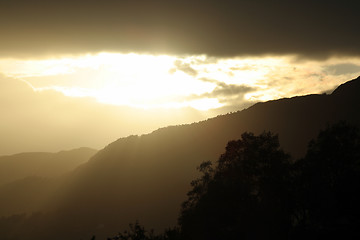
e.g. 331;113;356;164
0;77;360;240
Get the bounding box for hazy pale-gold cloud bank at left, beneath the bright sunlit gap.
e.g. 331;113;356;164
0;74;206;155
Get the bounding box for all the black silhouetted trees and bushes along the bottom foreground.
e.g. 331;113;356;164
109;122;360;240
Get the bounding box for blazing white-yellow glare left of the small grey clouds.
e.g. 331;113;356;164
0;53;221;110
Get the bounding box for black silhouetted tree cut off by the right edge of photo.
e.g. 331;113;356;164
294;122;360;239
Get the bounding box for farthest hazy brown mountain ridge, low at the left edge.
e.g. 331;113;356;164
0;147;97;185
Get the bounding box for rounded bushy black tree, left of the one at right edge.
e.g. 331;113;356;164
179;132;291;240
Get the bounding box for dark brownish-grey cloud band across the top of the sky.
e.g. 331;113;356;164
0;0;360;58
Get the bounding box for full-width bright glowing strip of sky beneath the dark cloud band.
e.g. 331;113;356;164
0;52;360;111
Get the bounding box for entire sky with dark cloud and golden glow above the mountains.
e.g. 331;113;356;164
0;0;360;155
